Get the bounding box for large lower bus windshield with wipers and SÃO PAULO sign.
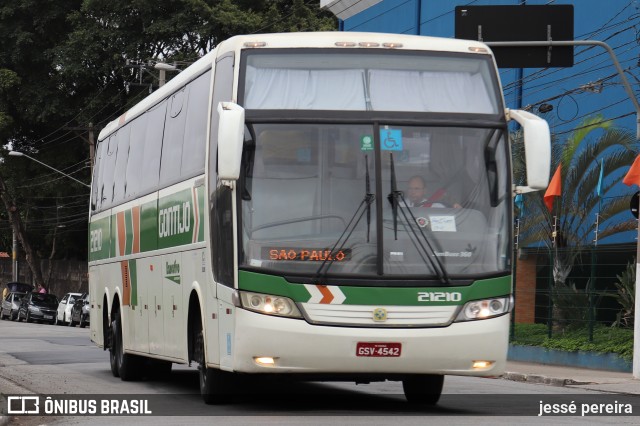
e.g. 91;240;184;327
239;122;511;280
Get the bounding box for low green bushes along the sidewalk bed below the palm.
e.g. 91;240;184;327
511;324;633;361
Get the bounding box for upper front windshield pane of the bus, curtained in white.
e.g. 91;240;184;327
243;49;500;114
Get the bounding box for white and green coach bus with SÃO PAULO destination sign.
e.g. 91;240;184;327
89;32;550;404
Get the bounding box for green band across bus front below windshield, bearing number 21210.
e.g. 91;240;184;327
238;271;511;306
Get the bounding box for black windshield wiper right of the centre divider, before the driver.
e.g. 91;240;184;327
387;153;451;284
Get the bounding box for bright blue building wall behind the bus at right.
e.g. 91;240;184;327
321;0;640;243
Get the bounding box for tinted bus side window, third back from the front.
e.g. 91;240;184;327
139;100;167;195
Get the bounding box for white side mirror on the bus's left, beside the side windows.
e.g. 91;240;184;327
218;102;244;180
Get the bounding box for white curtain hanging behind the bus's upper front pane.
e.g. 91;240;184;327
245;66;498;114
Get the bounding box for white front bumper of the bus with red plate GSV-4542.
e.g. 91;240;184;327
231;309;509;376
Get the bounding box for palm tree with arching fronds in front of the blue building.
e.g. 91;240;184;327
512;116;637;328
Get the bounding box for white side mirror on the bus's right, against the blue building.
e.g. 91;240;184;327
507;110;551;193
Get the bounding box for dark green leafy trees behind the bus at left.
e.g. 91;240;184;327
0;0;337;284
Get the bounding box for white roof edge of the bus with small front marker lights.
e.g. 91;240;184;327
98;31;491;140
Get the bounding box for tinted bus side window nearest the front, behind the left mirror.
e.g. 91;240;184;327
181;71;211;176
